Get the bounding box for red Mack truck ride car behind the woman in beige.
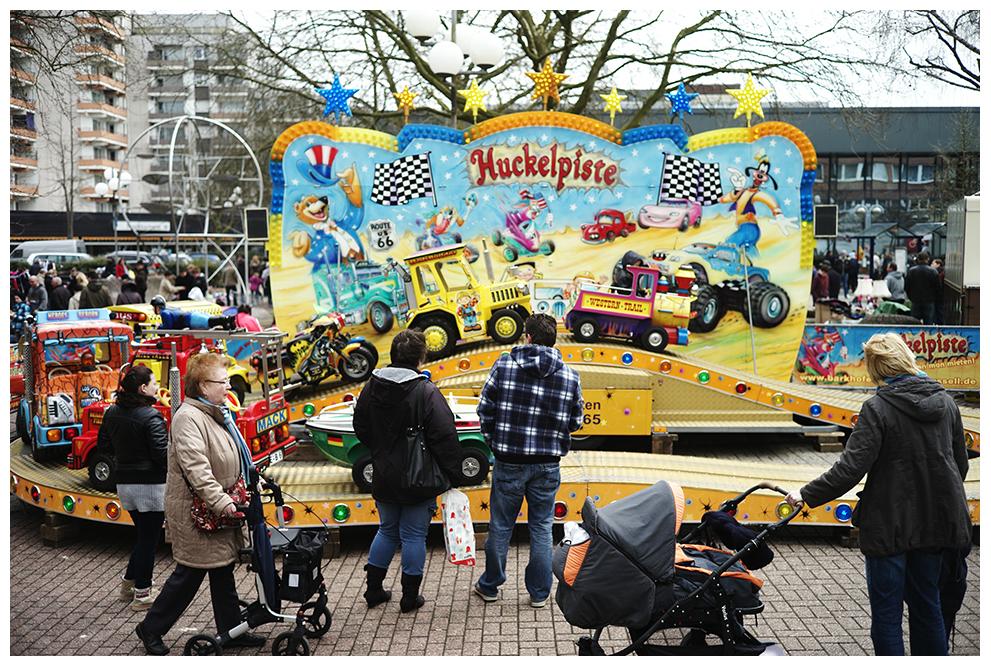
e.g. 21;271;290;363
68;326;296;491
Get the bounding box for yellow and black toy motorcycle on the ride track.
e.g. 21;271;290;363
251;313;378;398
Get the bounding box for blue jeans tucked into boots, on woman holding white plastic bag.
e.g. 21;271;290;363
368;498;437;576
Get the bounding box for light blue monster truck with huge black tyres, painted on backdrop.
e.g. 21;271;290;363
650;243;791;333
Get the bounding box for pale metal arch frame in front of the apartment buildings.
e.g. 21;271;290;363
115;115;264;295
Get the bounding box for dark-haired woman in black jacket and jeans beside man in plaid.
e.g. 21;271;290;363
354;329;463;613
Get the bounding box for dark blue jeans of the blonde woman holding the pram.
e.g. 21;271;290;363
865;549;947;656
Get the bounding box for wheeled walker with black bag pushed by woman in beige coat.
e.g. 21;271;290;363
183;474;331;655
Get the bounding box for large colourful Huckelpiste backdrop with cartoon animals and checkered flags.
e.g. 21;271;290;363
269;98;816;380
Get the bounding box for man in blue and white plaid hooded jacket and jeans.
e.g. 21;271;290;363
475;313;583;608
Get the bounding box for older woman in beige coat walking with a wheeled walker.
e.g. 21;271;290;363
135;353;265;655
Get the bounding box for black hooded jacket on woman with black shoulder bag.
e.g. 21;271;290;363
353;364;464;505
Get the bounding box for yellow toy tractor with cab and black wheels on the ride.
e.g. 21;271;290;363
403;243;530;360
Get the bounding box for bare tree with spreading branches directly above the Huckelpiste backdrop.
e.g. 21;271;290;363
202;10;900;133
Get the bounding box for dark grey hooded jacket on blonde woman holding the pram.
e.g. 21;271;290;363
801;375;971;557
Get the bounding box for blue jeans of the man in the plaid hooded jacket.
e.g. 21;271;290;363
478;461;561;601
